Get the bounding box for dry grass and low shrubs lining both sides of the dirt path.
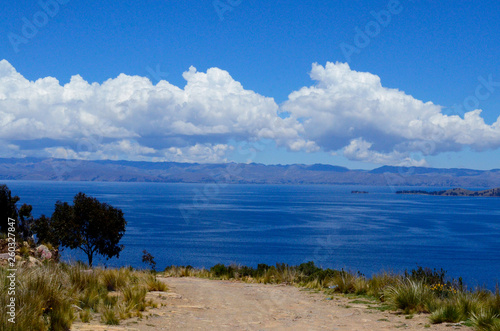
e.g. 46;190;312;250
0;260;500;331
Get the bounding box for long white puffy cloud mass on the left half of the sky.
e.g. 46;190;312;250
0;60;317;162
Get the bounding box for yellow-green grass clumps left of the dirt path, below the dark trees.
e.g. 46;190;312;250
0;261;167;331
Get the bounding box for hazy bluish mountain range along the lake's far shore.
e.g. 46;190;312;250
0;158;500;188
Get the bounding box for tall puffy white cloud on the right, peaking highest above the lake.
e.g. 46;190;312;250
282;62;500;165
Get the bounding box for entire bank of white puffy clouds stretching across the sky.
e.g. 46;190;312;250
0;60;500;165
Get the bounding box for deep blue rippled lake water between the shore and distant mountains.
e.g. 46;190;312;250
3;181;500;287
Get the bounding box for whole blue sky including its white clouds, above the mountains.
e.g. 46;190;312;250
0;0;500;169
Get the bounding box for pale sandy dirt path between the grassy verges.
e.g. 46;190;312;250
73;278;472;331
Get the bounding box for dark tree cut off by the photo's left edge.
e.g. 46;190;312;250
0;185;33;240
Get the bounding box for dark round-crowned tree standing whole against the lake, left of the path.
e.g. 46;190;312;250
51;192;127;267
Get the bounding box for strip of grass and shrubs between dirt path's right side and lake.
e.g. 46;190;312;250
165;262;500;331
